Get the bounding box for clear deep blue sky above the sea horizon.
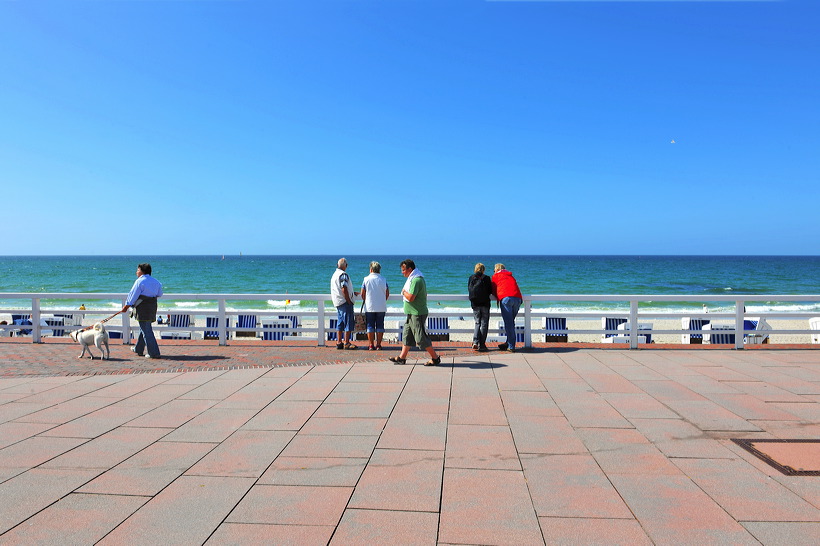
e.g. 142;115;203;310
0;0;820;255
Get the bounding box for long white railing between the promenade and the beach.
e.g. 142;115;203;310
0;292;820;349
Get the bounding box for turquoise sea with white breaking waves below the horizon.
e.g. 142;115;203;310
0;255;820;311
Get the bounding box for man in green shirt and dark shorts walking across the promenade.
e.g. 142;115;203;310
390;260;441;366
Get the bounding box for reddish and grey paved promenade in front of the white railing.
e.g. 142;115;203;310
0;341;820;546
